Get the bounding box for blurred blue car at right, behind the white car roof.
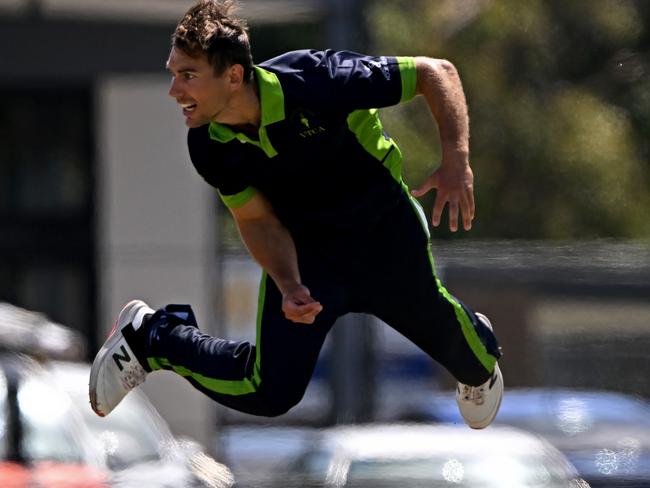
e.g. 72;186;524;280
401;388;650;488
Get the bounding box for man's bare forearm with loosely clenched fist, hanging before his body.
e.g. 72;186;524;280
230;192;323;324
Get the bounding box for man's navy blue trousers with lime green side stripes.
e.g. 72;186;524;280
145;194;500;416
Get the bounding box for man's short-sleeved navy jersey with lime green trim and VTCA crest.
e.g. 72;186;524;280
188;50;416;235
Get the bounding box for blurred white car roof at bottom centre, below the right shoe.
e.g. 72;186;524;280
275;424;589;488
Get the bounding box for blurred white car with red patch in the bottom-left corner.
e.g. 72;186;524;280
0;352;110;488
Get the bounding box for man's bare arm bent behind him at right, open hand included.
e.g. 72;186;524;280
411;57;475;232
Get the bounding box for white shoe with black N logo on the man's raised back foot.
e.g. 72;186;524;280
89;300;154;417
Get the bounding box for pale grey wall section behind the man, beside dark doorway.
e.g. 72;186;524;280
96;75;216;446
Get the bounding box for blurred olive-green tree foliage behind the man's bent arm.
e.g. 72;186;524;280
366;0;650;239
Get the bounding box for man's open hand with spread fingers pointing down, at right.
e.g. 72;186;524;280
411;156;475;232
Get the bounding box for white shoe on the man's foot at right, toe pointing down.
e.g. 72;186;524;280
456;313;503;429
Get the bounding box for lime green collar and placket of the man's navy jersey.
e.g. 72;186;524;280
209;66;285;157
